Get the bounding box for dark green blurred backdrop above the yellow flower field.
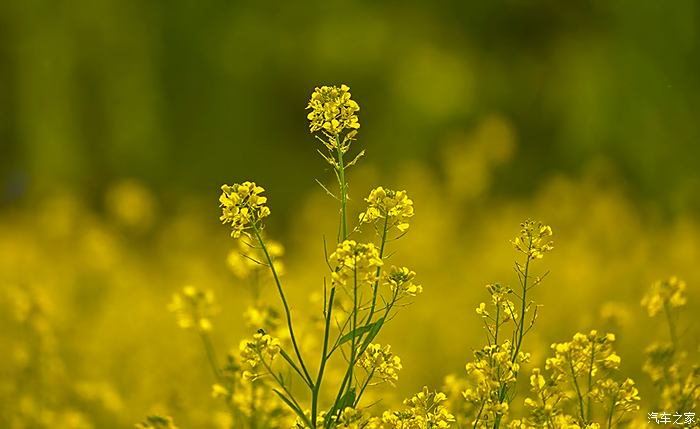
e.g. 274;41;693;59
0;0;700;214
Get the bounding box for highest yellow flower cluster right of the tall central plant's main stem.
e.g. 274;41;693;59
360;186;413;232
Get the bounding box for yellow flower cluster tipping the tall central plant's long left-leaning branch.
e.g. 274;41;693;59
219;182;270;238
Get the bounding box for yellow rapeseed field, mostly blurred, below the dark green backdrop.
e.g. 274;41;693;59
0;85;700;429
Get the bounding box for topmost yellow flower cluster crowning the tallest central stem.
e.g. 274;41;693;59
306;85;360;137
